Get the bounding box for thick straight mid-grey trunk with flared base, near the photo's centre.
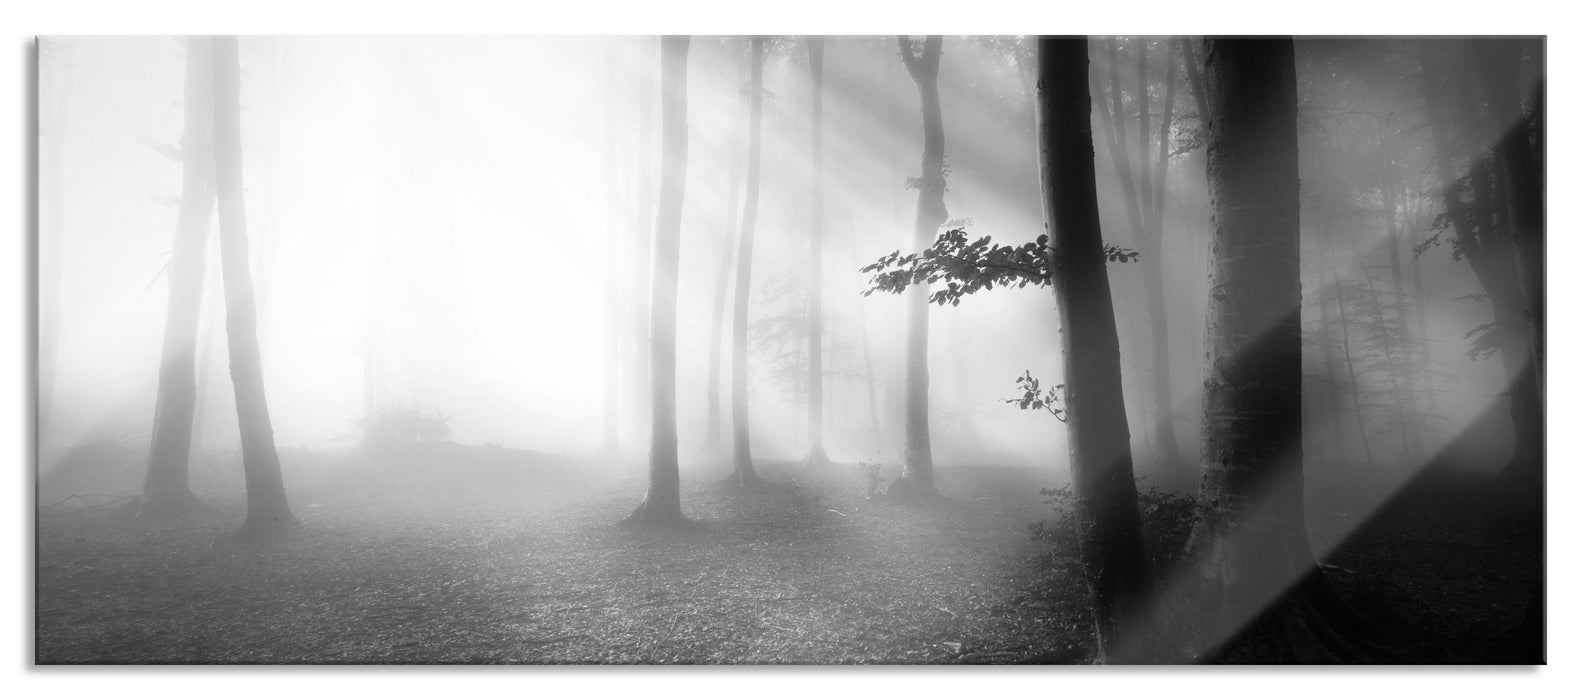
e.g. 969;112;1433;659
623;36;690;527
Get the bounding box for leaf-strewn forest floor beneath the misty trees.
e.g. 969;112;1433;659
35;445;1541;664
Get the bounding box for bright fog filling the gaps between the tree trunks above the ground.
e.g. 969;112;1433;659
40;36;1531;467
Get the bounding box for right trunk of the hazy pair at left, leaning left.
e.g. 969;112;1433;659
214;36;297;540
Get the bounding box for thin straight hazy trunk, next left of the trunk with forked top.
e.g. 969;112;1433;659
802;36;829;467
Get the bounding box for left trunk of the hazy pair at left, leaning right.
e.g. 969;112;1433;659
138;36;215;518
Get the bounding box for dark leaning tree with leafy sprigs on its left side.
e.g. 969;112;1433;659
862;38;1150;660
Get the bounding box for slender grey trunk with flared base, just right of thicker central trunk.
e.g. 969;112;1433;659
728;36;764;486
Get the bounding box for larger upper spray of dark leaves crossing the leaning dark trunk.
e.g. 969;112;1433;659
862;226;1139;306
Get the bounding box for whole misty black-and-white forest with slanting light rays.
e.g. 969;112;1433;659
32;35;1547;665
